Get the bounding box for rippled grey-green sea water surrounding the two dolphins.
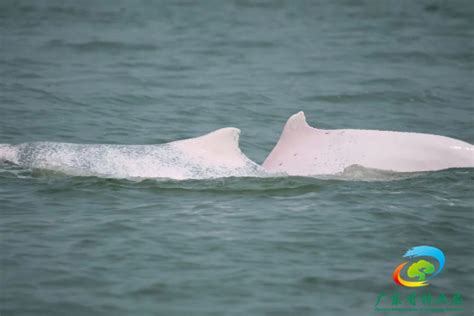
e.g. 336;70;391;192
0;1;474;316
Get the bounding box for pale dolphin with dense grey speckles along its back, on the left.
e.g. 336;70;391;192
0;127;264;180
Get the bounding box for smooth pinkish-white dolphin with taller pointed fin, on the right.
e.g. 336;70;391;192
263;112;474;176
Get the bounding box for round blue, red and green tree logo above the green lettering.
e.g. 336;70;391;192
392;246;445;287
